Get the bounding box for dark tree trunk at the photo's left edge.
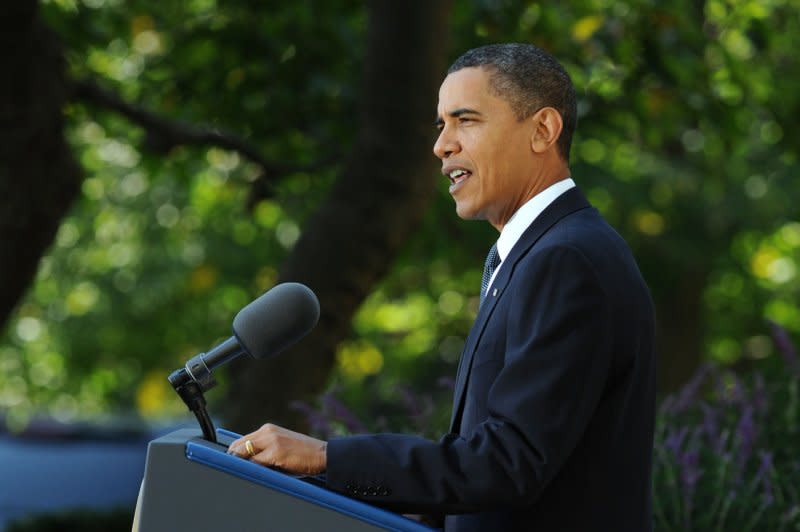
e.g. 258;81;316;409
0;1;81;324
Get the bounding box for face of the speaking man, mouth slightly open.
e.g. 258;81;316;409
433;68;536;229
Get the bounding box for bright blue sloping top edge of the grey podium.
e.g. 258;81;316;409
186;429;435;532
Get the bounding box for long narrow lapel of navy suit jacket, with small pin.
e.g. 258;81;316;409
449;187;590;432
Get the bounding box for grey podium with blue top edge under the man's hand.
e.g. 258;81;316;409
134;429;434;532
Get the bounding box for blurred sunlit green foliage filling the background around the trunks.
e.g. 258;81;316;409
0;0;800;426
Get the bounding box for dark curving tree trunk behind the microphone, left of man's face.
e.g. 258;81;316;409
226;0;450;431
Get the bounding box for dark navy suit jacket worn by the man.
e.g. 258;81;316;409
327;188;655;532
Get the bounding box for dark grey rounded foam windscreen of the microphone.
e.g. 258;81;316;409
233;283;319;358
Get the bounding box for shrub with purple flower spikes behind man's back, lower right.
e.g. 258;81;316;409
653;326;800;532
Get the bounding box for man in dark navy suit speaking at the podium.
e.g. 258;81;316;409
231;44;655;531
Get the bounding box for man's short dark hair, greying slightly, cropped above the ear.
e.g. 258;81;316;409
447;43;578;162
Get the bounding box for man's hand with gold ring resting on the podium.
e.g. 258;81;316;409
228;423;328;475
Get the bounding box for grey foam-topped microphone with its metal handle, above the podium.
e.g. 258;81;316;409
169;283;319;391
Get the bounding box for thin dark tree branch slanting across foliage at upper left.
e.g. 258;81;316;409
65;79;338;188
